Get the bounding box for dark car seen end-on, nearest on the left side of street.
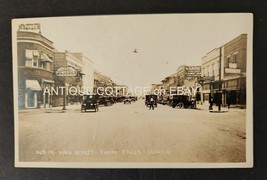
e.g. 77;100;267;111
81;95;99;112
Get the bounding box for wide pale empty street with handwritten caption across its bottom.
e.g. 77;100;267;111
18;100;246;162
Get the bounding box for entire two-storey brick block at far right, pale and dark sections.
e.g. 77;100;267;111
201;34;247;107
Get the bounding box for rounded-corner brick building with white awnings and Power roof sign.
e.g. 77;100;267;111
17;24;55;109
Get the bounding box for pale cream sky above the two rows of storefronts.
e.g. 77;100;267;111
14;14;252;87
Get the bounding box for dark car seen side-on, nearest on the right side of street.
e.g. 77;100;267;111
171;95;196;109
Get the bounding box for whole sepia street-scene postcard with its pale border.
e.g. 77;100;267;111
12;13;253;168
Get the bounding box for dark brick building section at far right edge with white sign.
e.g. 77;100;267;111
222;34;247;107
